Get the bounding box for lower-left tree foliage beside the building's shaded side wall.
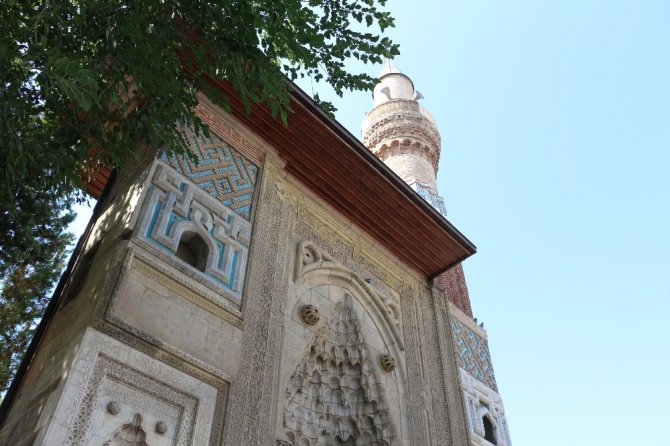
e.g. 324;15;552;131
0;177;74;394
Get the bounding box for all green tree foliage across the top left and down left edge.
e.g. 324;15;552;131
0;0;398;388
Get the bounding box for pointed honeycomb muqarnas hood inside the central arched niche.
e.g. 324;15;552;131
284;295;395;446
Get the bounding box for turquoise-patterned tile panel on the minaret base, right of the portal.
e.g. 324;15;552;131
451;317;498;391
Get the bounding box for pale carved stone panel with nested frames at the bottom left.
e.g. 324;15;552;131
44;329;218;446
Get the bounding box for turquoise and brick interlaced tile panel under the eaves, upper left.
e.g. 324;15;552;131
161;127;258;221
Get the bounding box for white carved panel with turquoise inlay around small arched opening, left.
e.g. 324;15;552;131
140;161;251;304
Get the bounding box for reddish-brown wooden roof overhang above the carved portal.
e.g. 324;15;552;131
89;79;476;279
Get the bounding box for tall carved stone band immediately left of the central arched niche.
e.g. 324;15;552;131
223;156;294;445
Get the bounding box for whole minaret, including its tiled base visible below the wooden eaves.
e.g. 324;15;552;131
362;60;512;446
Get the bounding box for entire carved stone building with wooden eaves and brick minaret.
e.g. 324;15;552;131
0;62;511;446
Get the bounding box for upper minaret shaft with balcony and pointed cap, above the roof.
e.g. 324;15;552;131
363;60;446;215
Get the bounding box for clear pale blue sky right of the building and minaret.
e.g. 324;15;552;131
71;0;670;446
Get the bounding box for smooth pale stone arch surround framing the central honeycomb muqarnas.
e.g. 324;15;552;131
276;242;409;444
